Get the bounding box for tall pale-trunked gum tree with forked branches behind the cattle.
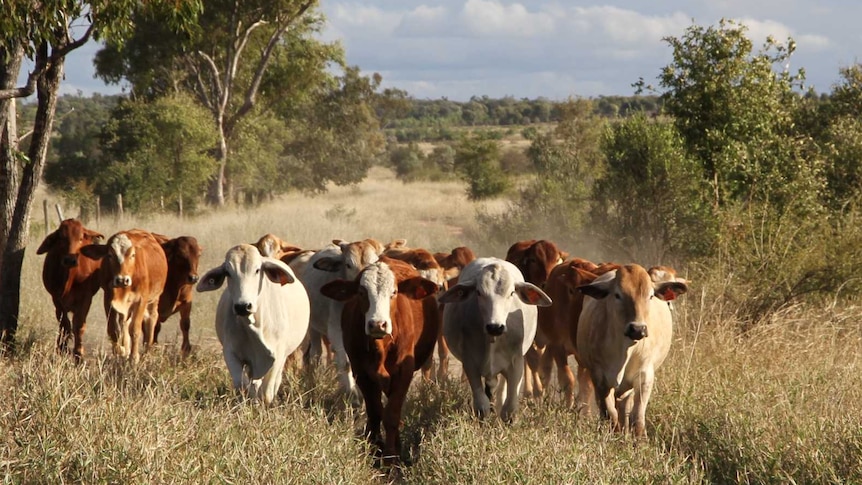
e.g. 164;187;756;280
98;0;323;206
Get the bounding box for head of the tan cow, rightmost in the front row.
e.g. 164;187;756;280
578;264;688;342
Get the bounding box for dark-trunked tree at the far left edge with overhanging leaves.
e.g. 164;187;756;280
0;0;198;346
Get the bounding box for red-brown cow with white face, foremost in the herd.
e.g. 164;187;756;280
321;256;440;462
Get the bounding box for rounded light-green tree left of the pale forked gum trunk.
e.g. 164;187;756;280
94;95;216;211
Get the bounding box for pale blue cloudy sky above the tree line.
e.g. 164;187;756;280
52;0;862;101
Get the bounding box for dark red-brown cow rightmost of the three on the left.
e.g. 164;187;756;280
153;234;202;356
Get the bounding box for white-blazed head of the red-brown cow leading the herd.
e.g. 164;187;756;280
320;258;437;339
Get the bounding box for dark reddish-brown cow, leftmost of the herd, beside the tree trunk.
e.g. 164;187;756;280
36;219;104;357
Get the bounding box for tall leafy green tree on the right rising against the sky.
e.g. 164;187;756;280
639;20;823;214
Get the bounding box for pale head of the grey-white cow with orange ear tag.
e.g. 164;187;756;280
438;260;551;337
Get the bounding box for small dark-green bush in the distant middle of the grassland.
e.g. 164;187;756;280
455;136;511;200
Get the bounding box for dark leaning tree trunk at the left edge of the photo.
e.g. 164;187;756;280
0;41;65;348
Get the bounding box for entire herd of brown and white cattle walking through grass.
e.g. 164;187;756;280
37;219;688;462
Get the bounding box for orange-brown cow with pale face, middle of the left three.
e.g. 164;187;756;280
81;229;168;363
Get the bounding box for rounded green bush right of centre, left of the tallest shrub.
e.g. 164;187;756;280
591;114;717;261
